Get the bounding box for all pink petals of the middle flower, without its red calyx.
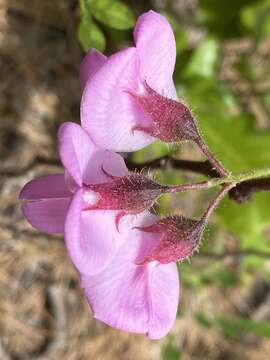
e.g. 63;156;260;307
20;123;131;274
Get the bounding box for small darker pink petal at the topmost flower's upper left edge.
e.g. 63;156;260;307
80;49;107;89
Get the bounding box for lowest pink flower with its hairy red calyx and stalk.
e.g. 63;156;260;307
81;184;233;339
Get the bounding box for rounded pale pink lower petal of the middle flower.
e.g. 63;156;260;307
65;190;124;275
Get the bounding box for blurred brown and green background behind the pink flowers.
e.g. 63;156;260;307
0;0;270;360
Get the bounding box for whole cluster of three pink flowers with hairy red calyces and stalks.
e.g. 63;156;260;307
20;11;227;339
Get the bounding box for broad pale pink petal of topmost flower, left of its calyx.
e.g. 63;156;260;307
81;48;155;151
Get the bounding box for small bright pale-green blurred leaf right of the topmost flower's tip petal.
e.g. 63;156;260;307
185;38;219;78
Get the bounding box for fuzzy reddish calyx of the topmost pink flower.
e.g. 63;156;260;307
128;81;200;143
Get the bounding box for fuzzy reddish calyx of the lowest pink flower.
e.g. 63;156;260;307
136;216;205;265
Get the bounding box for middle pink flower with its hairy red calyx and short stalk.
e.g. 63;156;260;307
20;123;192;274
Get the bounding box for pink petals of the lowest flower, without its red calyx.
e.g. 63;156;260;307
81;215;179;339
